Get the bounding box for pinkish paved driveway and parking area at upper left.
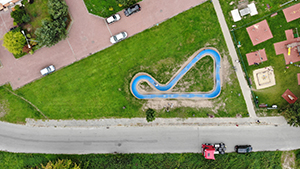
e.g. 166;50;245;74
0;0;205;89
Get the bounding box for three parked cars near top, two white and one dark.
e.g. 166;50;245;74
106;4;141;44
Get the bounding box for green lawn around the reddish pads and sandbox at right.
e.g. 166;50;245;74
218;1;300;112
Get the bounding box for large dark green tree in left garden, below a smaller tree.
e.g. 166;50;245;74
35;20;67;47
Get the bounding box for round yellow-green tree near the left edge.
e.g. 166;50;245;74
3;31;26;55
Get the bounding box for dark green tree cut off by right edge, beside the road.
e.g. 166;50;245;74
283;102;300;127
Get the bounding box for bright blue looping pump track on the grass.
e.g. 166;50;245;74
130;49;221;99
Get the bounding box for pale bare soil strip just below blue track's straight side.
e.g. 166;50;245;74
142;99;213;110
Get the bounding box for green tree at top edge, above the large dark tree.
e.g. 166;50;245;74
48;0;68;20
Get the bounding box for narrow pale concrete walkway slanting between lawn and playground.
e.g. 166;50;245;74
212;0;257;118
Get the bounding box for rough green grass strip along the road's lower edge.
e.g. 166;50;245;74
0;151;282;169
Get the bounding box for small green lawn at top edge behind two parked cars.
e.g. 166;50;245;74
84;0;141;18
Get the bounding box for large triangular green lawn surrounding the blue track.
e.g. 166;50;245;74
0;2;248;123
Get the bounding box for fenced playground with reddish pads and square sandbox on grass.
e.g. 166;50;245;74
226;2;300;109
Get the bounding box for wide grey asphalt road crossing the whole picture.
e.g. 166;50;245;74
0;122;300;154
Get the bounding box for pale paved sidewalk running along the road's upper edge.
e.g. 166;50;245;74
26;116;287;128
